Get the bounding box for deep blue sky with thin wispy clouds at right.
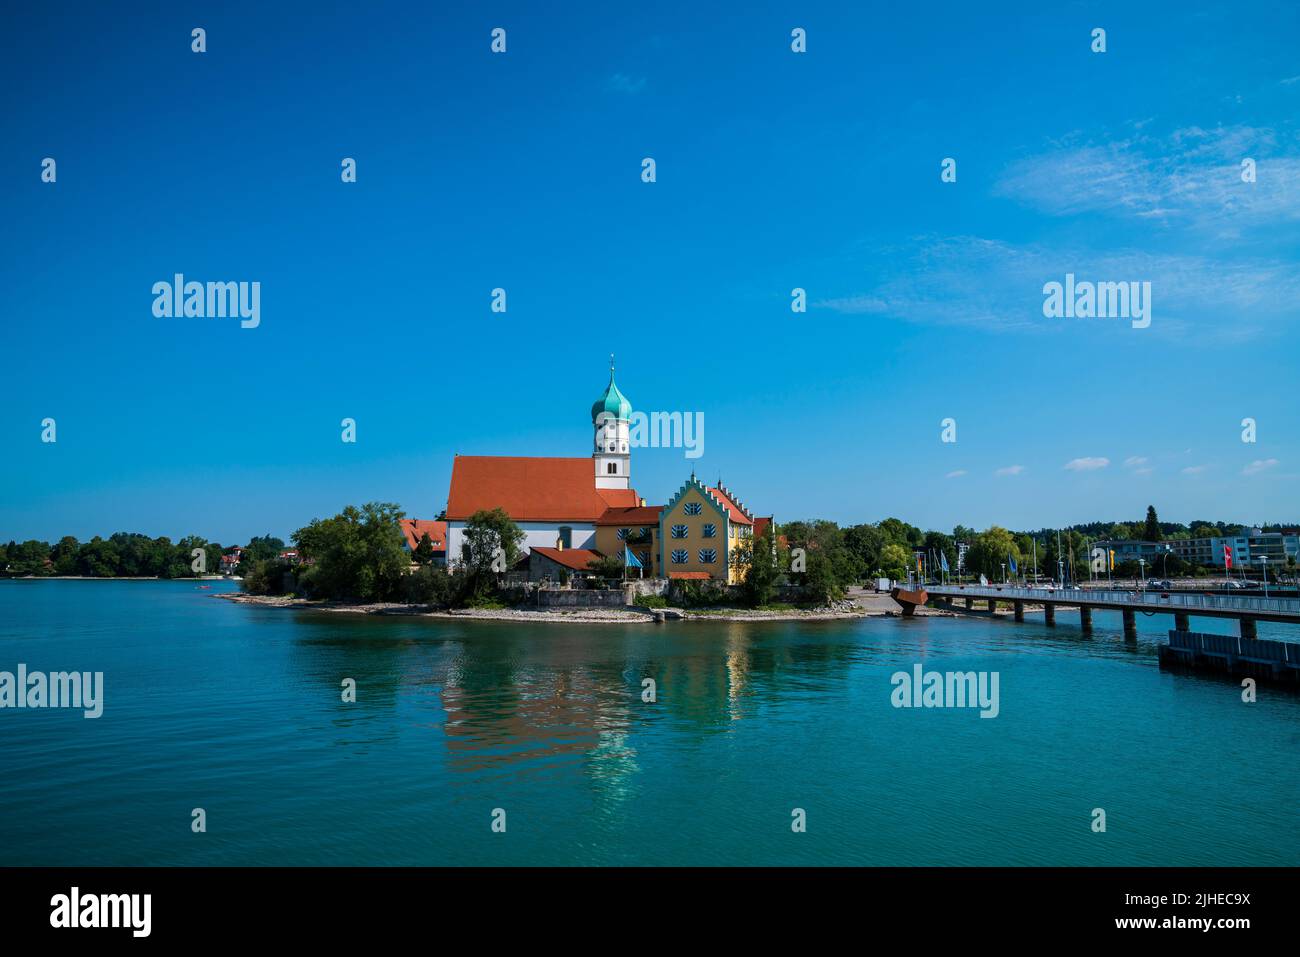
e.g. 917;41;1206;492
0;3;1300;542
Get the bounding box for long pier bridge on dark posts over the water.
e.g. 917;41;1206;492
926;584;1300;638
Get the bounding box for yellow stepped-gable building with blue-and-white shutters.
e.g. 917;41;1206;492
658;475;754;585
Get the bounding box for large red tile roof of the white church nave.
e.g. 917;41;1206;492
447;455;641;521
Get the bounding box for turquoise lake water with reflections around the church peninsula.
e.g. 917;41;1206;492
0;581;1300;865
